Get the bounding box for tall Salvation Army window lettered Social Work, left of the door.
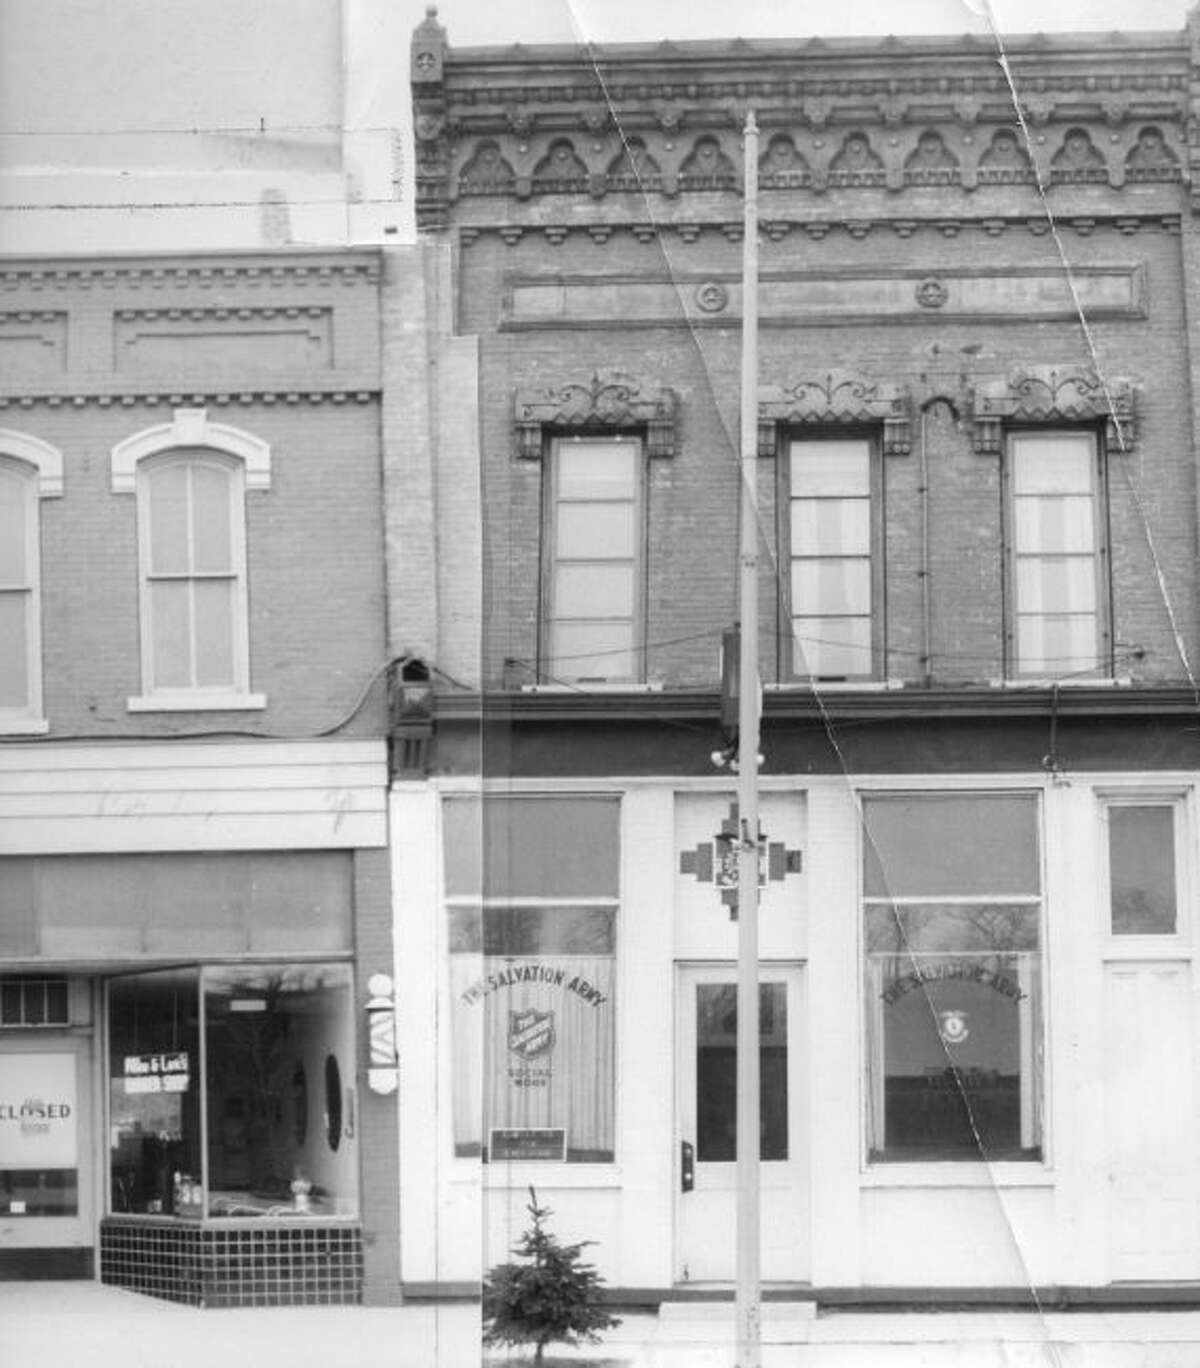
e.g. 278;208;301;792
443;795;620;1163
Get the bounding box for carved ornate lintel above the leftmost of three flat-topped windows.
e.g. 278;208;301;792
513;373;676;461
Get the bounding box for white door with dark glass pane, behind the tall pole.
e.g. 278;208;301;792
675;964;809;1282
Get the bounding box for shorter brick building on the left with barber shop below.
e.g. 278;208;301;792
0;249;400;1305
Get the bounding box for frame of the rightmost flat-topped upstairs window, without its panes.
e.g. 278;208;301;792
1003;427;1112;684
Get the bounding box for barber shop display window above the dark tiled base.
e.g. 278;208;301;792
108;963;358;1218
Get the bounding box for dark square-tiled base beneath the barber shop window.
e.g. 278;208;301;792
100;1216;363;1306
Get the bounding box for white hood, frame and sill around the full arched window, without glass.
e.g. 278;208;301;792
111;409;271;713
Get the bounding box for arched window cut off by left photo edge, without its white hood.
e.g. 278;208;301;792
0;456;41;729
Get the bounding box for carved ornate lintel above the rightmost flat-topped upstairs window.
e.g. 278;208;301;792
971;365;1137;454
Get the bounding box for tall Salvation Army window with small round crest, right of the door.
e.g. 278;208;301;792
862;793;1043;1161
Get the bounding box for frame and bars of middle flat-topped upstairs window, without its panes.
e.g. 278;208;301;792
779;431;884;688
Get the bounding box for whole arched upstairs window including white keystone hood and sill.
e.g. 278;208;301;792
112;409;270;711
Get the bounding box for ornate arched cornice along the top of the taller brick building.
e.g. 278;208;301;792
413;15;1200;230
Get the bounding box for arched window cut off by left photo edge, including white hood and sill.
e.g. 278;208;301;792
0;432;63;735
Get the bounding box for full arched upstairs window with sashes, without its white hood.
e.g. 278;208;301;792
137;450;249;695
